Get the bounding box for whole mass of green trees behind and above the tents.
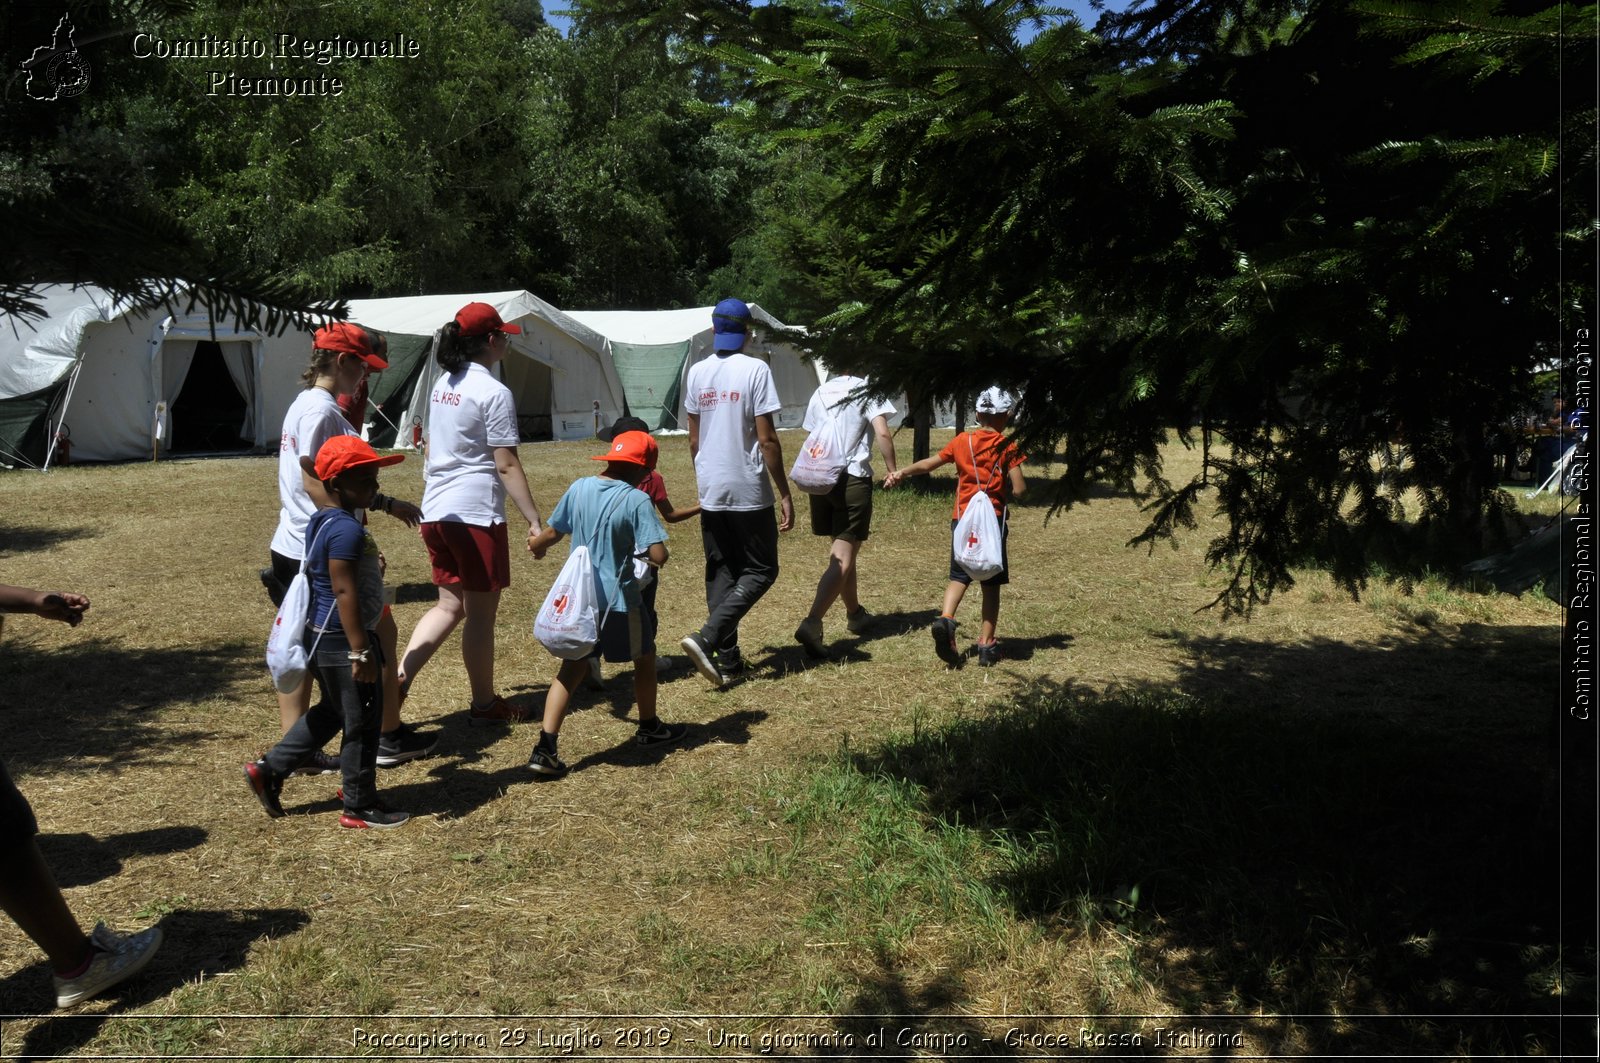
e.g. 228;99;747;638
0;0;1597;610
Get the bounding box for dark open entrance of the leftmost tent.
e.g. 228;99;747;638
162;339;254;453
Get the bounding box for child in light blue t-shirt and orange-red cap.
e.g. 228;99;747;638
528;432;688;778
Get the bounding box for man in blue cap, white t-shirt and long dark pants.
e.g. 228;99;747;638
682;299;795;687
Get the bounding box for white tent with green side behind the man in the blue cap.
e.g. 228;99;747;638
568;306;822;429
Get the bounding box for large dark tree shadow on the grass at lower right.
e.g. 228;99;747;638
856;629;1594;1055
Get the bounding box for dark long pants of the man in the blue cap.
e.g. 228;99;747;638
699;509;778;661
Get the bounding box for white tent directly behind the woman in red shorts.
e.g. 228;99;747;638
350;291;624;443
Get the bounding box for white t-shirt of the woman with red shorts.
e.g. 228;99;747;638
422;362;522;528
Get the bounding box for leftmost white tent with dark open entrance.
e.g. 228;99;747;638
0;285;310;467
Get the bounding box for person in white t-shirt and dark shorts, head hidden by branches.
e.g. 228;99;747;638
795;376;896;658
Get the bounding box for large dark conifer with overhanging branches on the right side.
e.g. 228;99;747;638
722;0;1594;610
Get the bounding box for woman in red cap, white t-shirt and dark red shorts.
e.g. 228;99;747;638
400;303;542;724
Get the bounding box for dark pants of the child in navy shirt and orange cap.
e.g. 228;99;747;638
262;631;384;808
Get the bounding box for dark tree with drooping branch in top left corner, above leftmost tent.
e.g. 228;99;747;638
0;0;342;328
